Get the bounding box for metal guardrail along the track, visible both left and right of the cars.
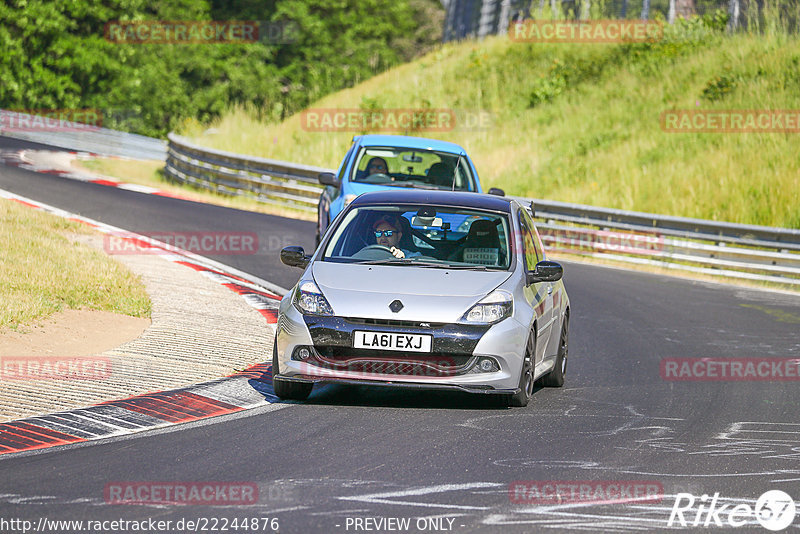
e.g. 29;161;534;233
165;134;800;285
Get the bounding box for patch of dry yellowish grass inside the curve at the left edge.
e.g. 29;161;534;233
0;199;150;329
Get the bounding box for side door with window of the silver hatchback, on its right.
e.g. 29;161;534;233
518;209;553;365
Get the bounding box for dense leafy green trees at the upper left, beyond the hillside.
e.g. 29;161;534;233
0;0;443;136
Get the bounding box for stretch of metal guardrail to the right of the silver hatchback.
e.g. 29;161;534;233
515;197;800;285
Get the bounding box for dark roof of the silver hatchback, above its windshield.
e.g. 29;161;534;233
351;188;514;213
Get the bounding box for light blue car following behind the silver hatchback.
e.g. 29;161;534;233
316;135;504;245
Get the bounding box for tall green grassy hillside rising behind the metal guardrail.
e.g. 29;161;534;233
181;15;800;228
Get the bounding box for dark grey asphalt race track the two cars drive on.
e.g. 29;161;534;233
0;138;800;533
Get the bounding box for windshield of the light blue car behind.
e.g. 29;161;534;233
351;147;475;191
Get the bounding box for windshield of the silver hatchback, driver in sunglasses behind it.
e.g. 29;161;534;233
321;205;511;270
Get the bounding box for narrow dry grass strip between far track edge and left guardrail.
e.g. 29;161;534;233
73;158;316;221
